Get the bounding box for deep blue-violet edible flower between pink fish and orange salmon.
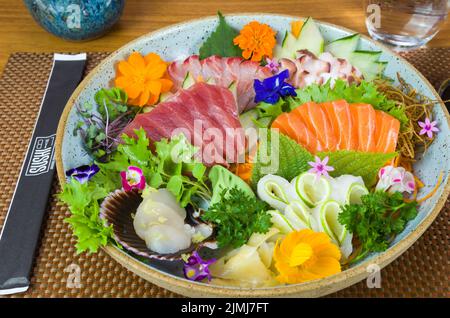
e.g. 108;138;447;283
253;70;297;104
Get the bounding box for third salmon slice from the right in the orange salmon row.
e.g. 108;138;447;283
320;99;358;150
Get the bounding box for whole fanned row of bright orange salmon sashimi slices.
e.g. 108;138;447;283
272;100;400;153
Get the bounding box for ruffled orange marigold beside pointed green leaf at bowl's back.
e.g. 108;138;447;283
233;21;276;62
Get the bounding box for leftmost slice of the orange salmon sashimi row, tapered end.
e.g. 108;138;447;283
271;112;324;153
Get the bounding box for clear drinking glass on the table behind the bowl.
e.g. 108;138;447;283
364;0;450;49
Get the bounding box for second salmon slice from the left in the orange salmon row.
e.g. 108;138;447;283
292;102;336;151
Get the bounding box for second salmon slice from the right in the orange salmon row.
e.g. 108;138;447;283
350;103;376;152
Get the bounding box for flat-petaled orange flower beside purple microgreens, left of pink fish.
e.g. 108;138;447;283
114;52;173;107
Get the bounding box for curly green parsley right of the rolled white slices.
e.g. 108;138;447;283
338;191;417;262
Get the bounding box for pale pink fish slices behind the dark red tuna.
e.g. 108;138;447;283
167;55;272;113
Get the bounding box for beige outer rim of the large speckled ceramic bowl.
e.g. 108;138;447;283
55;12;450;297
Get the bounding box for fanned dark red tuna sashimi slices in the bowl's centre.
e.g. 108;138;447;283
123;83;245;166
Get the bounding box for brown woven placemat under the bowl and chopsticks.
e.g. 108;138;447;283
0;49;450;297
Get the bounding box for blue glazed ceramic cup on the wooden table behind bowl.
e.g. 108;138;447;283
24;0;125;41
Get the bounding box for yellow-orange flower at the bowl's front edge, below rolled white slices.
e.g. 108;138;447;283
273;229;341;284
